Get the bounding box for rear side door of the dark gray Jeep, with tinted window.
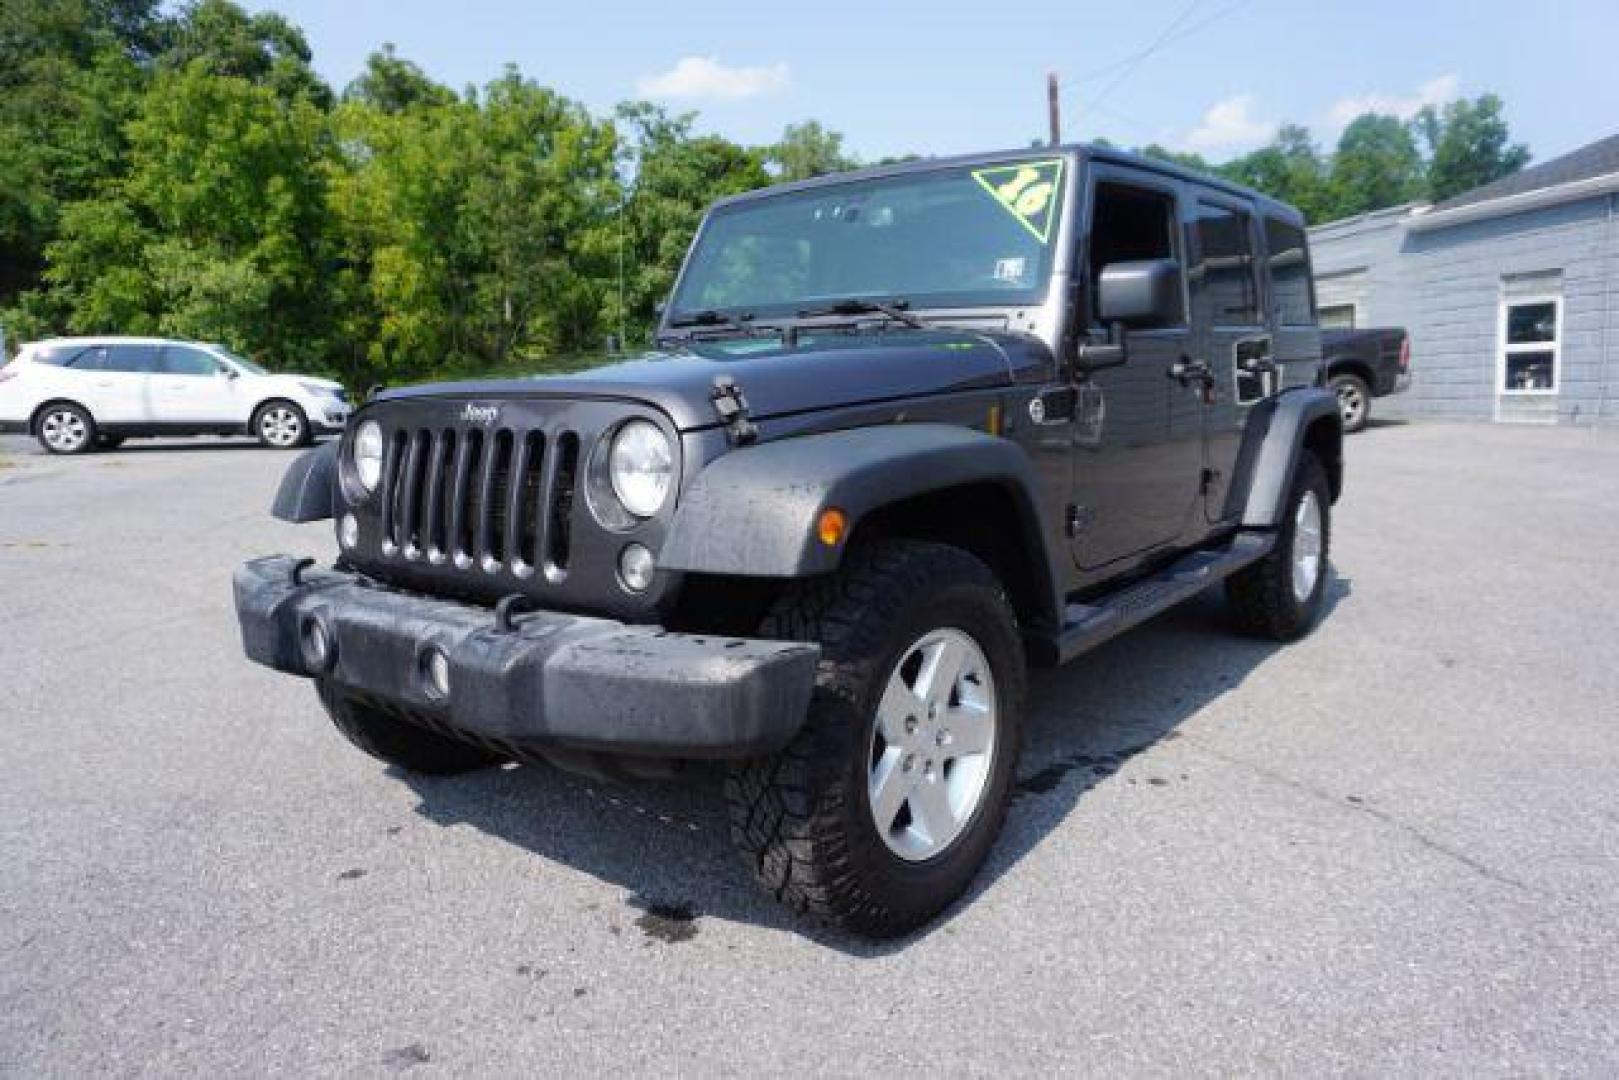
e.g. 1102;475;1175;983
1190;199;1276;521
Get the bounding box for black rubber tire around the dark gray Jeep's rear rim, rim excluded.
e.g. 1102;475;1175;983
1226;450;1332;641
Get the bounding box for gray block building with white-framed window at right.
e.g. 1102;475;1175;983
1310;136;1619;423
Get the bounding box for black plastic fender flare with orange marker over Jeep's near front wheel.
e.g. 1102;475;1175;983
659;424;1054;588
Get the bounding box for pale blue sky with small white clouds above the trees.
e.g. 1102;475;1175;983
248;0;1619;160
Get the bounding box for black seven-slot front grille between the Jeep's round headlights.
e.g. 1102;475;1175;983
379;427;580;580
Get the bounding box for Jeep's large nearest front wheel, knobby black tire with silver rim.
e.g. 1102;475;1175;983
725;541;1026;938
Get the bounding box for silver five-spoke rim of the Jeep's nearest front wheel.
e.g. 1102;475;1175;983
866;628;997;863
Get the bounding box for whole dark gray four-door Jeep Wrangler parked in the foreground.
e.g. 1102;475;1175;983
235;147;1342;936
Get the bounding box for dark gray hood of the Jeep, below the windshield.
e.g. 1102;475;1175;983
382;329;1051;431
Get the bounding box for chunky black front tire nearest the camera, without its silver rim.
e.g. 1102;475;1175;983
725;541;1026;938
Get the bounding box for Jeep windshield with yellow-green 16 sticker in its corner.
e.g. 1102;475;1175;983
670;159;1064;322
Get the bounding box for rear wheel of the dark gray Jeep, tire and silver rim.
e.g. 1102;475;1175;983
1226;450;1332;641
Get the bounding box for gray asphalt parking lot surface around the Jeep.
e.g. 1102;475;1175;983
0;424;1619;1077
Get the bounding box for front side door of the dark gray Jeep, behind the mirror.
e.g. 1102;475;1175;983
1070;165;1203;570
